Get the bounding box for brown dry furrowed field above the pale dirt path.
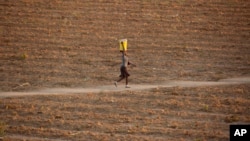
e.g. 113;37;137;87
0;0;250;91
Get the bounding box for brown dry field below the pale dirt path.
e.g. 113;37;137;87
0;84;250;141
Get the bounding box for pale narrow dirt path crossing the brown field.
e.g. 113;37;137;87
0;77;250;97
